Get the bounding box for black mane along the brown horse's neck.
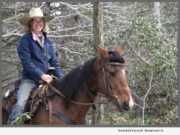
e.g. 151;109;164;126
52;58;96;102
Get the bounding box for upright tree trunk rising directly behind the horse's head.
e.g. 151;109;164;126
92;0;104;124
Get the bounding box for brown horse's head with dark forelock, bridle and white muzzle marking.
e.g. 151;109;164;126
94;48;134;110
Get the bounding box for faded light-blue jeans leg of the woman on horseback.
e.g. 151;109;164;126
9;79;36;123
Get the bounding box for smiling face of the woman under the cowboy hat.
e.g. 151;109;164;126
32;17;45;33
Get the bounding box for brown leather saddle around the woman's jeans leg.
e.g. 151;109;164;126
3;80;55;119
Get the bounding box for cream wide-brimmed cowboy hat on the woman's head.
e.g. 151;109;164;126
18;7;52;26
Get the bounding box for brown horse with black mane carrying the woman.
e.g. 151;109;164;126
1;48;134;125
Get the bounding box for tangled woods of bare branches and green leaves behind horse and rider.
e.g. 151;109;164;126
0;2;177;126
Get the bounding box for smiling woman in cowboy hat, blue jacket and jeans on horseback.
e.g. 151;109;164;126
9;8;62;124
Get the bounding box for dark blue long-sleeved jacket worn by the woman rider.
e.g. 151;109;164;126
17;33;63;82
